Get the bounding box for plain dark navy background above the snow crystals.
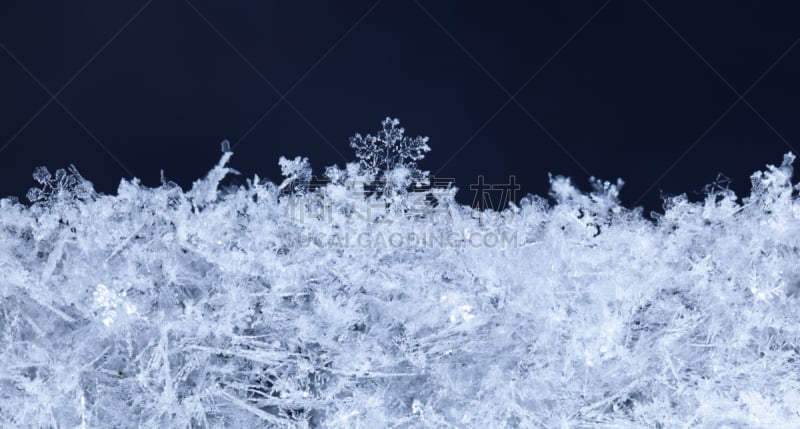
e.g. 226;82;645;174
0;0;800;211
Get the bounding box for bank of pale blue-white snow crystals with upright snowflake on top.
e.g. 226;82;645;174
0;119;800;429
